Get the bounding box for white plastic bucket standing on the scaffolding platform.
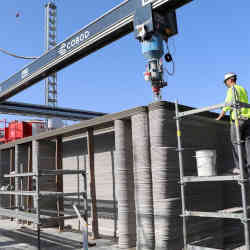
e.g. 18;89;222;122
195;149;216;176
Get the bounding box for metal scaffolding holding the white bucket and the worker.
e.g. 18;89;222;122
175;87;250;250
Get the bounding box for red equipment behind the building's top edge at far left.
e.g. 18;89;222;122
0;120;44;143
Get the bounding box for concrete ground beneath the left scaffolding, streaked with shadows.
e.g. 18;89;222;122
0;219;125;250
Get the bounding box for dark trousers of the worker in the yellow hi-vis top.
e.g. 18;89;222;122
230;119;250;174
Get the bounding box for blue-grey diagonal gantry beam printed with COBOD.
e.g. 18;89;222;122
0;0;192;101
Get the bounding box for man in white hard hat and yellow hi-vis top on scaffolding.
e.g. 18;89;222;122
216;73;250;175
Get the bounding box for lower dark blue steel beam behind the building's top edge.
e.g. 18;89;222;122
0;102;105;121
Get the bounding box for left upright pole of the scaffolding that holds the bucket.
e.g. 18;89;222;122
175;101;187;250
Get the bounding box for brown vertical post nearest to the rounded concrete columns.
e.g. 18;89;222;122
87;128;99;239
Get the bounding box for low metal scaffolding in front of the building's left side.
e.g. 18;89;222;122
0;169;88;250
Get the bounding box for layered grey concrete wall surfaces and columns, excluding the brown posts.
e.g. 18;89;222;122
0;102;244;250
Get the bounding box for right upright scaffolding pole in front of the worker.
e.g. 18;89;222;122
233;87;250;250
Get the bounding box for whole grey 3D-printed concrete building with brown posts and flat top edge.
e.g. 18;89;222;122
0;102;248;249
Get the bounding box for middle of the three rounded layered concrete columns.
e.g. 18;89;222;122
132;110;155;250
